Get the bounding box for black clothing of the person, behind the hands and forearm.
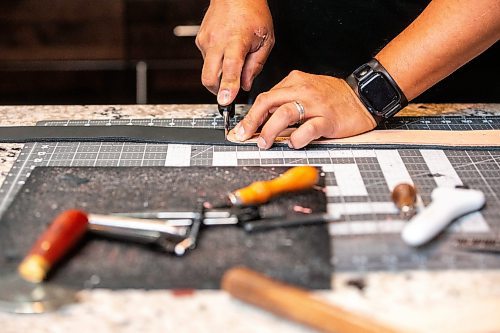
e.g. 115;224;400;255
258;0;500;103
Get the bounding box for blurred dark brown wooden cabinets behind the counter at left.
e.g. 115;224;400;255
0;0;214;104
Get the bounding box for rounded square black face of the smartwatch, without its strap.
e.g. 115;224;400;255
359;73;399;113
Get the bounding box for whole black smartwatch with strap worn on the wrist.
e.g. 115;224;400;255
346;59;408;124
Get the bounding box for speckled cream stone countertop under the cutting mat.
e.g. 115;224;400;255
0;104;500;333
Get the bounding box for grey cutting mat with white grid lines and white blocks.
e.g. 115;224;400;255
0;116;500;271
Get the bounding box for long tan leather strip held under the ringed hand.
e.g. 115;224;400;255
227;128;500;148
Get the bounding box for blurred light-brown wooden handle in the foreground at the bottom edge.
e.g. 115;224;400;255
222;267;396;333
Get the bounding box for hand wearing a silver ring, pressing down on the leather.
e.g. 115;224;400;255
234;71;377;149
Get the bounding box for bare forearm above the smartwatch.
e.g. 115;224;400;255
376;0;500;100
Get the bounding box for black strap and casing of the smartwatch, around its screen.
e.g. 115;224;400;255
346;59;408;124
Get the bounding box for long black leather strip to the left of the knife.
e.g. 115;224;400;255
0;125;236;145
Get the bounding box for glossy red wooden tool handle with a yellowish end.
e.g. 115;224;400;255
18;210;88;283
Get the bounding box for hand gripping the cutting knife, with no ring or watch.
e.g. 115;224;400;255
196;0;274;105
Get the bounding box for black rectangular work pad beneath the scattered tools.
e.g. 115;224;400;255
0;167;331;289
